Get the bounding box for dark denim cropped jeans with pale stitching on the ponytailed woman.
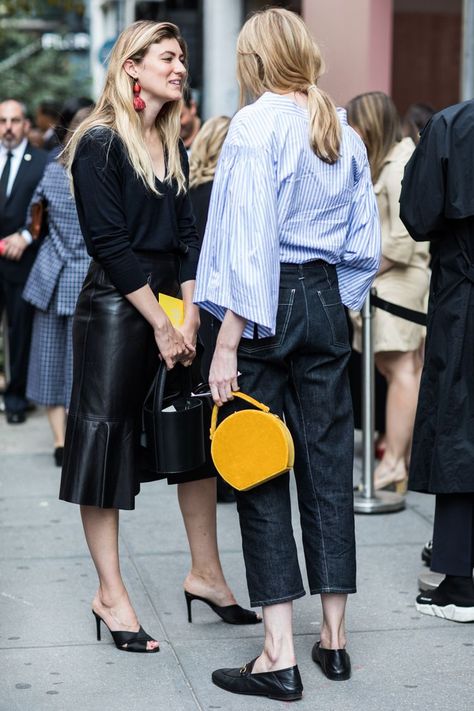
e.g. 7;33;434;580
237;261;356;606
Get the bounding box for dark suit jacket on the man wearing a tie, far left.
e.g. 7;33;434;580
0;143;49;284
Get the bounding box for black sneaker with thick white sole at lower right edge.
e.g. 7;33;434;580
416;575;474;622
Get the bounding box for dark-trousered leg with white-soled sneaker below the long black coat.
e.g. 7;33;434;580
416;493;474;622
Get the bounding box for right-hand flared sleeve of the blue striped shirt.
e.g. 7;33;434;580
336;156;382;310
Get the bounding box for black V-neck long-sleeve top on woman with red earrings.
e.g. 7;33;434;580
72;127;199;294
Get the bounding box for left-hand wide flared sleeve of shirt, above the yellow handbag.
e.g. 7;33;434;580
194;126;280;338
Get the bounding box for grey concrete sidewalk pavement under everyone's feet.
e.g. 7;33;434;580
0;411;474;711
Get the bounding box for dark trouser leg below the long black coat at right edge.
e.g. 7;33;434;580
431;494;474;577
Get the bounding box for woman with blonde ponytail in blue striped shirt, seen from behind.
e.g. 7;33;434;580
194;9;380;700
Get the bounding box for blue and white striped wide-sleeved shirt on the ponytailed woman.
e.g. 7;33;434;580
194;92;380;338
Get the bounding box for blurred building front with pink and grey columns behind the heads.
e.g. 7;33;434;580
90;0;474;118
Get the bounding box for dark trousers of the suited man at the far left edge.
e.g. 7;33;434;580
0;276;33;412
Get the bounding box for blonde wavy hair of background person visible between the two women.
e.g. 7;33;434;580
189;116;230;188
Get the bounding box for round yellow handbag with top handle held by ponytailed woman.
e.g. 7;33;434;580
211;392;295;491
